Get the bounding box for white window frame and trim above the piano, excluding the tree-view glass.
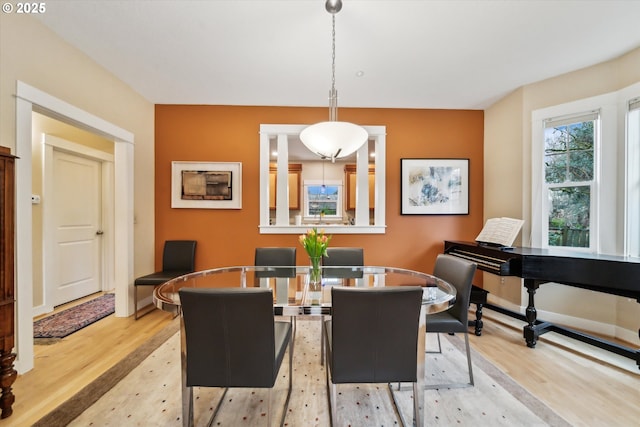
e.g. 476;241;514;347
531;82;640;257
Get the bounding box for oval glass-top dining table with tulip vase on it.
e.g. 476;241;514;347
153;266;456;426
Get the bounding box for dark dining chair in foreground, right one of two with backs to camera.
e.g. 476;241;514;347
323;286;422;426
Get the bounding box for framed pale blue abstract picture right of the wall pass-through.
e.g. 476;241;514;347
400;158;469;215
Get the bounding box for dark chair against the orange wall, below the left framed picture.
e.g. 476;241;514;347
133;240;196;320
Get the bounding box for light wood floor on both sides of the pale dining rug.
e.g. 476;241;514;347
0;301;640;427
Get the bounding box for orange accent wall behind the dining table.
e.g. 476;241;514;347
155;105;484;273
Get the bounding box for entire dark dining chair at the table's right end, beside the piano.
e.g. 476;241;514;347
426;254;477;389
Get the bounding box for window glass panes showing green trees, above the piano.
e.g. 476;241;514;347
543;113;599;248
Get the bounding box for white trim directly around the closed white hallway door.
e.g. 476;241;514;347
33;134;115;316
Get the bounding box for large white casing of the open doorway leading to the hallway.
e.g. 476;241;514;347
15;80;134;374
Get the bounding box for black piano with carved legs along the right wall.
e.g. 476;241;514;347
444;241;640;368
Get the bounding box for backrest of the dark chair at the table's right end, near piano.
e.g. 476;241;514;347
427;254;477;325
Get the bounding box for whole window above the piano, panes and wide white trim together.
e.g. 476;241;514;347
531;83;640;256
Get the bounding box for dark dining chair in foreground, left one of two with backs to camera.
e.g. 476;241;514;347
179;288;293;426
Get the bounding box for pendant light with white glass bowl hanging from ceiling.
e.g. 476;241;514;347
300;0;369;162
